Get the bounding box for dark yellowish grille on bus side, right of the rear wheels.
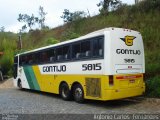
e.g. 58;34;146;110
85;78;101;98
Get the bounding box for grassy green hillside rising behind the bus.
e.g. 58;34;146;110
0;0;160;97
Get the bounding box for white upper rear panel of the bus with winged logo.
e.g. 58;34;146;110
109;28;145;75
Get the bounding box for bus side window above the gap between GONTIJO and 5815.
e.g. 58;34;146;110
72;43;81;59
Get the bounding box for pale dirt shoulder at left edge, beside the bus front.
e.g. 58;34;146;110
0;78;14;89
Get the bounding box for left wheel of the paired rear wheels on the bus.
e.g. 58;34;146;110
59;83;71;100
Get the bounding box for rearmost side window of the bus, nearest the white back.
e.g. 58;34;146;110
93;38;103;57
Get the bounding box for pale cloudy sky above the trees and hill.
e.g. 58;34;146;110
0;0;135;33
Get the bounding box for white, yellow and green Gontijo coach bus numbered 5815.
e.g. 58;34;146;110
14;27;145;102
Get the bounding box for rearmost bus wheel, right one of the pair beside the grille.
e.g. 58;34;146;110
73;84;84;103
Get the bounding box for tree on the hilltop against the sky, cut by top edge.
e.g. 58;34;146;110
97;0;122;14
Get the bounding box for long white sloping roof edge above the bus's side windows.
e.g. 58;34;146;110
16;27;133;56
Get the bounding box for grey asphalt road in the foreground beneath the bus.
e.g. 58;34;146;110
0;88;160;114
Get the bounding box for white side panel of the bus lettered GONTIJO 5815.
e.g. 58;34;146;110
38;59;105;75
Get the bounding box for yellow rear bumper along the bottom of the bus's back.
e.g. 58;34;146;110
102;86;145;100
